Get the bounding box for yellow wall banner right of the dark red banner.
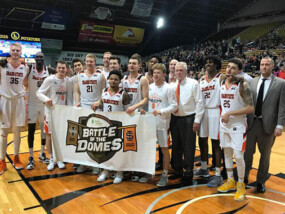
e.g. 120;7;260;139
114;25;144;45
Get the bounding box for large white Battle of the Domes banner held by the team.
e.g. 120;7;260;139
51;105;156;174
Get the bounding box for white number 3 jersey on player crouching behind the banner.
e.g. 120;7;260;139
101;88;125;112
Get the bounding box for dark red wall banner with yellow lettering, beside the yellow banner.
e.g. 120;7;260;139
78;21;114;44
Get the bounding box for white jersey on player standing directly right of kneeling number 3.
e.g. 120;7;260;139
123;75;143;106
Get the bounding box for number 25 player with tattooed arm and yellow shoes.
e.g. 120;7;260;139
218;59;254;201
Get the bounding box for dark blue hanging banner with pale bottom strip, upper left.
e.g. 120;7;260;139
42;7;68;30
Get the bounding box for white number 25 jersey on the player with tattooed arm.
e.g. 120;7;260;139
220;81;246;133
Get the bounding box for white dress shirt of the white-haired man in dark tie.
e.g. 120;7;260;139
171;77;204;123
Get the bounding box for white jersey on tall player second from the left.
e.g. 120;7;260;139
29;65;49;104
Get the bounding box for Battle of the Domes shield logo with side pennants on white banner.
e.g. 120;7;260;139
66;114;137;164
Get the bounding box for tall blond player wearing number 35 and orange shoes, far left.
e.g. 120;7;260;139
0;43;27;175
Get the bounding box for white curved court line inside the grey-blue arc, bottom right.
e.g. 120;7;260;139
176;194;285;214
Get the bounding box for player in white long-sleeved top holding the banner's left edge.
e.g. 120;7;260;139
37;61;72;171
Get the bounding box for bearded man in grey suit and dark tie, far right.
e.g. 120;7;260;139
245;57;285;193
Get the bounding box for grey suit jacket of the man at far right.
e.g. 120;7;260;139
247;75;285;134
